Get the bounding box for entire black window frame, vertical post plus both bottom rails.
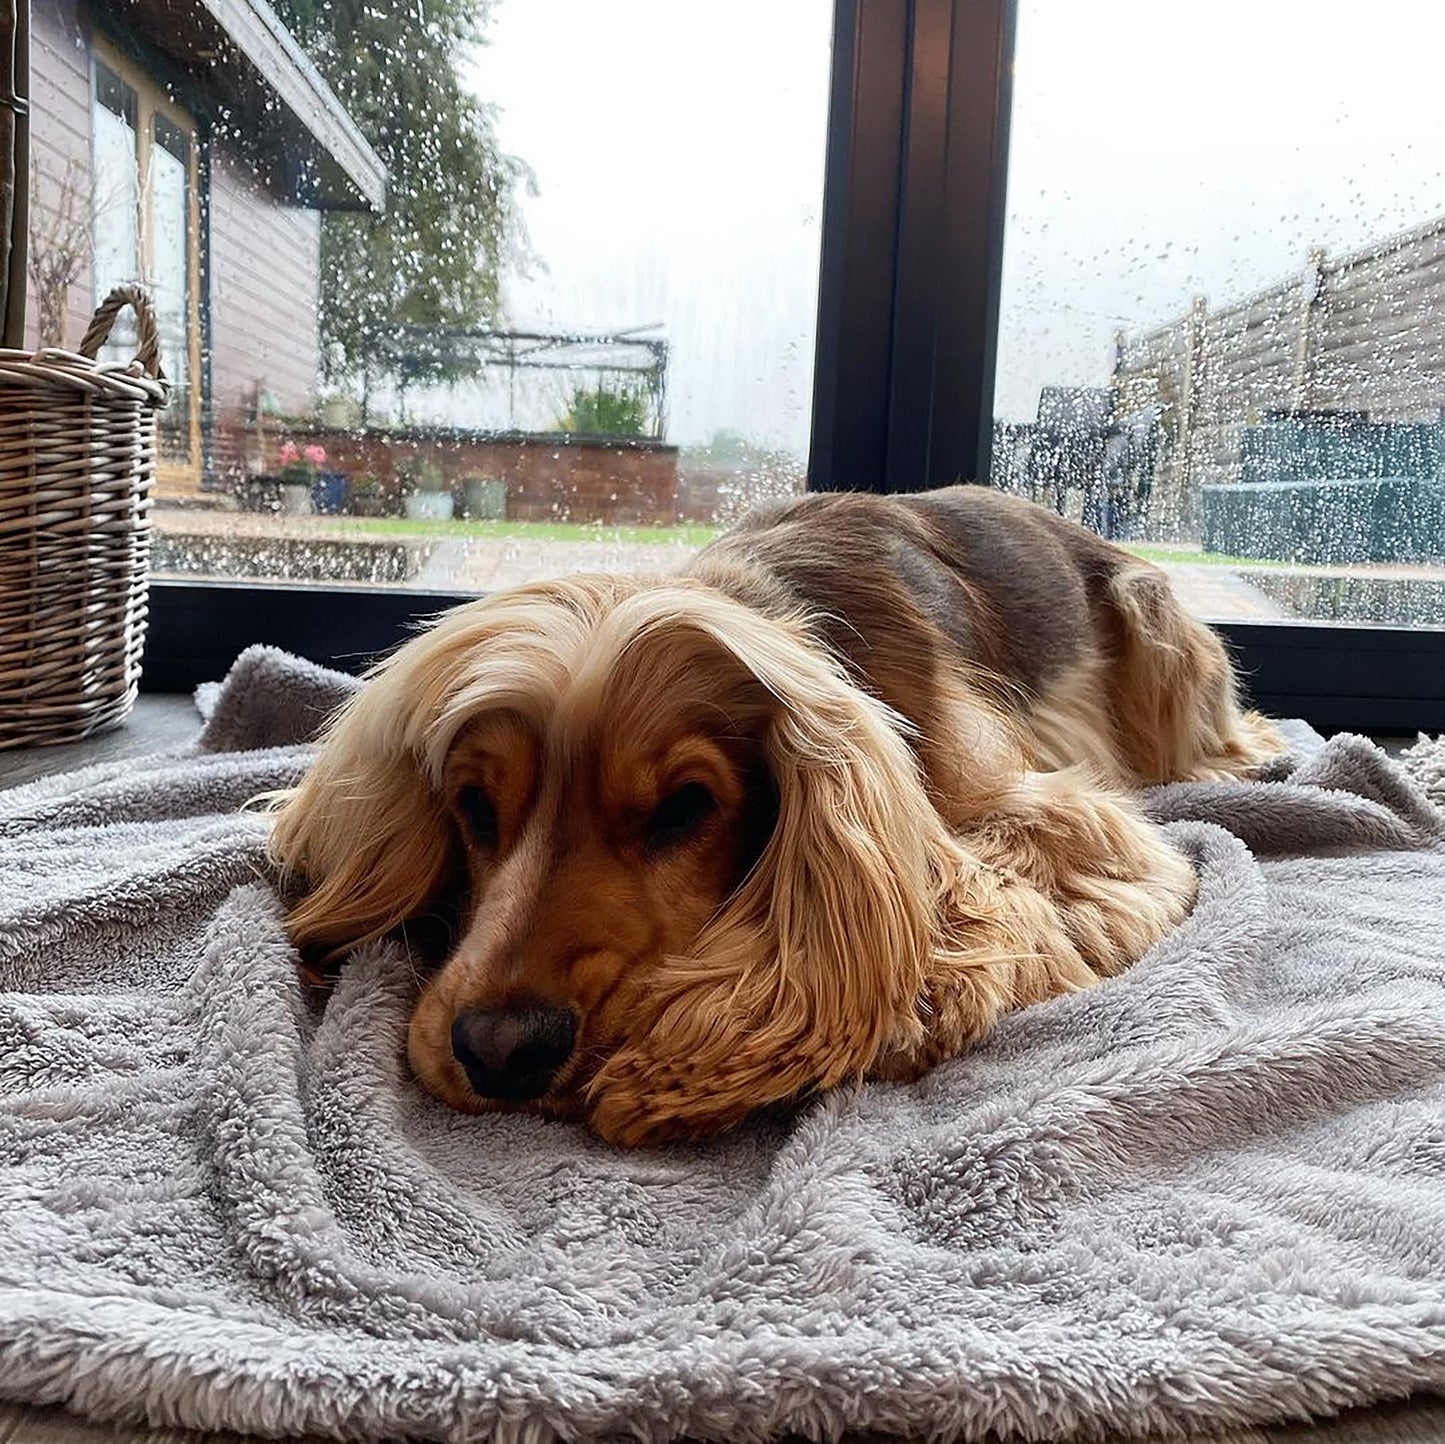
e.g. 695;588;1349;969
142;0;1445;733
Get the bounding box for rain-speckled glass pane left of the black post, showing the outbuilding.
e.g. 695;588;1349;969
25;0;832;591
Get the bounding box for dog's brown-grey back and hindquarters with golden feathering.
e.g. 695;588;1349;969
686;486;1279;782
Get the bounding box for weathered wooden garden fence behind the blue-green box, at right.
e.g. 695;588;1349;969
1114;220;1445;541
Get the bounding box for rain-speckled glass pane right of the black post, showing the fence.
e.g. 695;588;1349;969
993;0;1445;626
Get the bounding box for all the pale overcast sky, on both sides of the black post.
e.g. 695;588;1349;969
474;0;1445;455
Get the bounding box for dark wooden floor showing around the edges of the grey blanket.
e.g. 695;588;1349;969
0;695;1445;1444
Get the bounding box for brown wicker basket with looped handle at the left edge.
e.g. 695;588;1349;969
0;286;168;749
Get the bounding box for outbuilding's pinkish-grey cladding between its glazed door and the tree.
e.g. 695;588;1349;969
210;145;321;426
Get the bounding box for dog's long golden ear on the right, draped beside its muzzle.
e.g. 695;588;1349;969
590;595;957;1143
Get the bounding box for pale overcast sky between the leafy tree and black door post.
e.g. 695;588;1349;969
474;0;832;455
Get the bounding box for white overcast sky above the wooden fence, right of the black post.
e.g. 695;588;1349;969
996;0;1445;419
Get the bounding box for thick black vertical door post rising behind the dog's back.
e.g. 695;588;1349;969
808;0;1016;491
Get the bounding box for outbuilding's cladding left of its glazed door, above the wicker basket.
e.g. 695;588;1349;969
25;0;95;347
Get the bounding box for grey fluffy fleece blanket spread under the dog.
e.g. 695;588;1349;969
0;652;1445;1441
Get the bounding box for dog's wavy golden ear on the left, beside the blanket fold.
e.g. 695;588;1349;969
270;668;454;957
